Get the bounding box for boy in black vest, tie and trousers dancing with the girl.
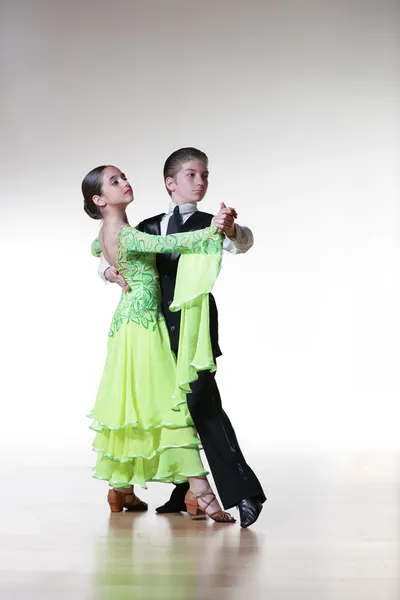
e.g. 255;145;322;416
99;148;265;528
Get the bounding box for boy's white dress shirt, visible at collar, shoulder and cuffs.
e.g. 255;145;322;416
98;202;254;283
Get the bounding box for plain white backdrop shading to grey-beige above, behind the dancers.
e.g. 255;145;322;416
0;0;400;464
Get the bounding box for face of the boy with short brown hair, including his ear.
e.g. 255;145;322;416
165;160;208;204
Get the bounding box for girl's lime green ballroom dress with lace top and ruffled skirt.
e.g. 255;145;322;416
89;225;222;488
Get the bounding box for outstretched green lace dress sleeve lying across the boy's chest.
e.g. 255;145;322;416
118;225;222;254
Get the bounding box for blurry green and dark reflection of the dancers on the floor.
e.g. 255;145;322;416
93;513;260;600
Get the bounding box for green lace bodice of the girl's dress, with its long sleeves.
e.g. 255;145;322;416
92;225;222;337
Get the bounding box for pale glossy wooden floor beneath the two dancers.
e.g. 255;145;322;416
0;455;400;600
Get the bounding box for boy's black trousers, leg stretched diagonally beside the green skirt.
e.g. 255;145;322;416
186;371;265;509
